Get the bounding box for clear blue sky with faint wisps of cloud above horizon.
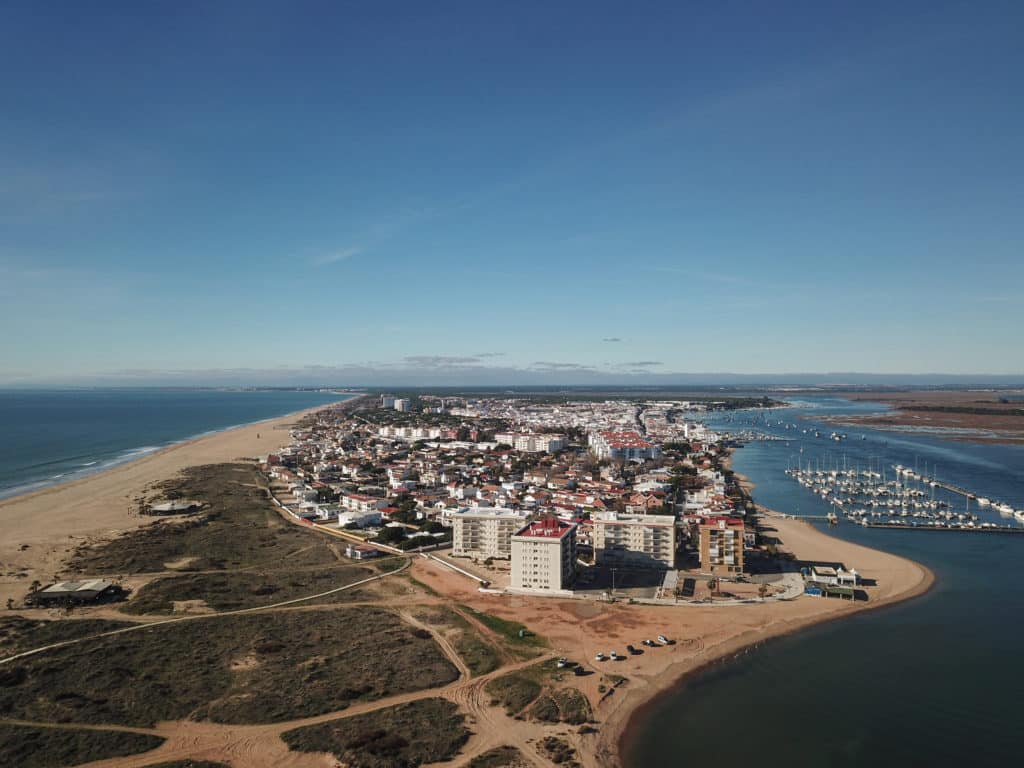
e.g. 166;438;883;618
0;0;1024;385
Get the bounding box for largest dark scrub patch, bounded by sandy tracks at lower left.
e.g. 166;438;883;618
0;608;458;726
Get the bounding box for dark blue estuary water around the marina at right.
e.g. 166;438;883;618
624;398;1024;768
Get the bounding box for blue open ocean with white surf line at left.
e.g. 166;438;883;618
0;388;351;499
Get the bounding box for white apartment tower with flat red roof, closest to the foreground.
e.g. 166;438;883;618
509;517;577;594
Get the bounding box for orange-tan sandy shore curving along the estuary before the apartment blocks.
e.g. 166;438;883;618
405;507;933;767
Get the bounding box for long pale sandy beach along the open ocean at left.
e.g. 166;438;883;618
0;406;335;604
